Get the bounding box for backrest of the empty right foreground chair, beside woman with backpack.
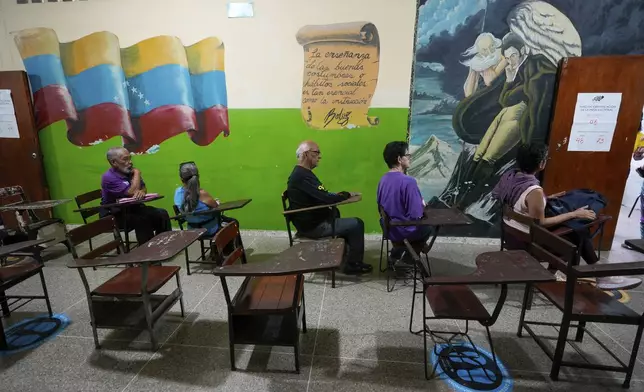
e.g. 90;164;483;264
529;223;579;273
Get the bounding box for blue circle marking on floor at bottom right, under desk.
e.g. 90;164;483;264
429;343;514;392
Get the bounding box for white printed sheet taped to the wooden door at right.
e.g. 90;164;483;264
568;93;622;152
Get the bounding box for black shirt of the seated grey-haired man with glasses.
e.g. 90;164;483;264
286;165;350;232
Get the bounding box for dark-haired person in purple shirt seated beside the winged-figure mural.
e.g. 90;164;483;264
377;142;432;258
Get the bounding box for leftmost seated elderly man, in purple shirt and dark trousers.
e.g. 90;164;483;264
100;147;172;244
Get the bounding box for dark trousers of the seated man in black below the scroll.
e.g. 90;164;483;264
301;217;364;265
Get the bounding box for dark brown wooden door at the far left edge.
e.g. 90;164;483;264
0;71;51;227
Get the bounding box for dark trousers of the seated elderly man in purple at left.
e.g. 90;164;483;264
115;205;172;244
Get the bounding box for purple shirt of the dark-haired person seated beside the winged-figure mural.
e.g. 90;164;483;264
377;172;425;242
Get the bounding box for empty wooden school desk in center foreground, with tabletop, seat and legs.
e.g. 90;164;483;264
214;238;345;373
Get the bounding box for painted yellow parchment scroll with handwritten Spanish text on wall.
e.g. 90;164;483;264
296;22;380;130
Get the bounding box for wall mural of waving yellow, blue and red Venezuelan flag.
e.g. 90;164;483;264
15;28;229;153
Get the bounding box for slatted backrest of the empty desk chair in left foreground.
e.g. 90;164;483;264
67;215;123;259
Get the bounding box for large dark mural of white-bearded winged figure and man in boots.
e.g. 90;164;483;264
409;0;644;237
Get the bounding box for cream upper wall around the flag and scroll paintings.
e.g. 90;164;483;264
0;0;416;108
